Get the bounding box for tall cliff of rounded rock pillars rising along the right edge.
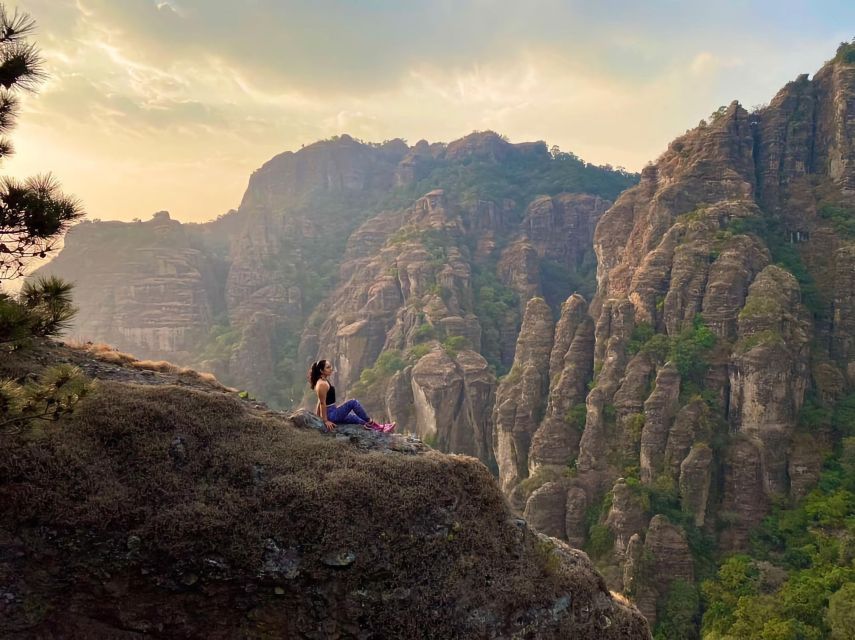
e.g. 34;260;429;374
497;51;855;622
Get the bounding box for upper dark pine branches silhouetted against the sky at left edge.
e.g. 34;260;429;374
0;4;83;280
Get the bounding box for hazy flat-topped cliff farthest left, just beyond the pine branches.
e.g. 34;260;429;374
33;211;227;362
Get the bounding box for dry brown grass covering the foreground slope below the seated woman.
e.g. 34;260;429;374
0;381;643;638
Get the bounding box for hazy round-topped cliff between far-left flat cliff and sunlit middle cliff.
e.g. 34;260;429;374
225;136;408;396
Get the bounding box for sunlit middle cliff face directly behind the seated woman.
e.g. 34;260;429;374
310;169;608;464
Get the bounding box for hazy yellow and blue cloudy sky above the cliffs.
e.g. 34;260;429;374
3;0;855;220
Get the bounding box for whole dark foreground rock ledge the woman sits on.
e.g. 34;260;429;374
0;343;650;640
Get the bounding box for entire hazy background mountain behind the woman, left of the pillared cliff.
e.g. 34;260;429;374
38;132;635;464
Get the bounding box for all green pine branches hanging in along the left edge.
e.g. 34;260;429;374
0;4;89;432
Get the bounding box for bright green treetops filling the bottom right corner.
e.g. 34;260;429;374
702;438;855;640
